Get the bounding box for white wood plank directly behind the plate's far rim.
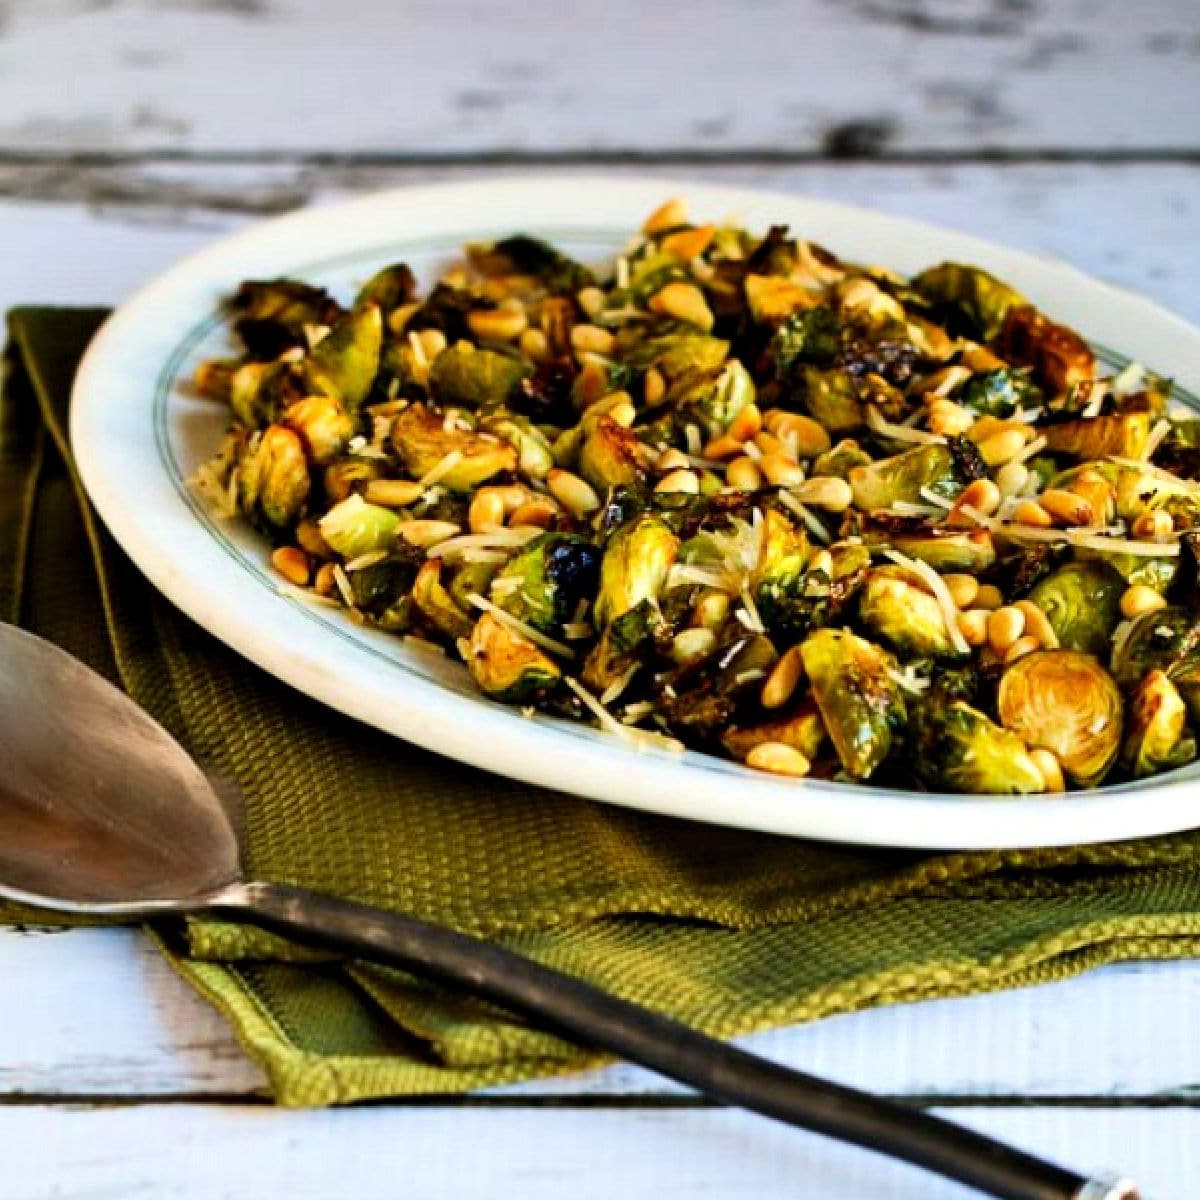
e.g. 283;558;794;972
0;164;1200;319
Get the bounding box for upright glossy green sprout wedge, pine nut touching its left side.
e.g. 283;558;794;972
800;629;906;779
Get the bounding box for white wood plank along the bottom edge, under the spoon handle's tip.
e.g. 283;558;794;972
0;1105;1200;1200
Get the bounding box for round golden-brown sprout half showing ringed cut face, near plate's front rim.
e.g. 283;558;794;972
997;650;1122;787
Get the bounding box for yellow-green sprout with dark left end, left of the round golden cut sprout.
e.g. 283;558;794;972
911;696;1045;796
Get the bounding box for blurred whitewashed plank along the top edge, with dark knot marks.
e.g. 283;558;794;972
0;0;1200;155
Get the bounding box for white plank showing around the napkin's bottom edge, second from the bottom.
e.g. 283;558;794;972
7;930;1200;1099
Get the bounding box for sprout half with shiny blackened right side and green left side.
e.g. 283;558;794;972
491;533;600;634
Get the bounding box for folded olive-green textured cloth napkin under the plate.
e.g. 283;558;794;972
7;308;1200;1105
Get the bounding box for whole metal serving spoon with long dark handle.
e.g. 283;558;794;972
0;624;1138;1200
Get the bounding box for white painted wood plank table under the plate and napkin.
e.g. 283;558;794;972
0;0;1200;1200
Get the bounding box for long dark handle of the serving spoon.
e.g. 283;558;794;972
205;883;1138;1200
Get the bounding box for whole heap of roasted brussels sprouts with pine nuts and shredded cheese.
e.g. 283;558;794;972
196;200;1200;793
